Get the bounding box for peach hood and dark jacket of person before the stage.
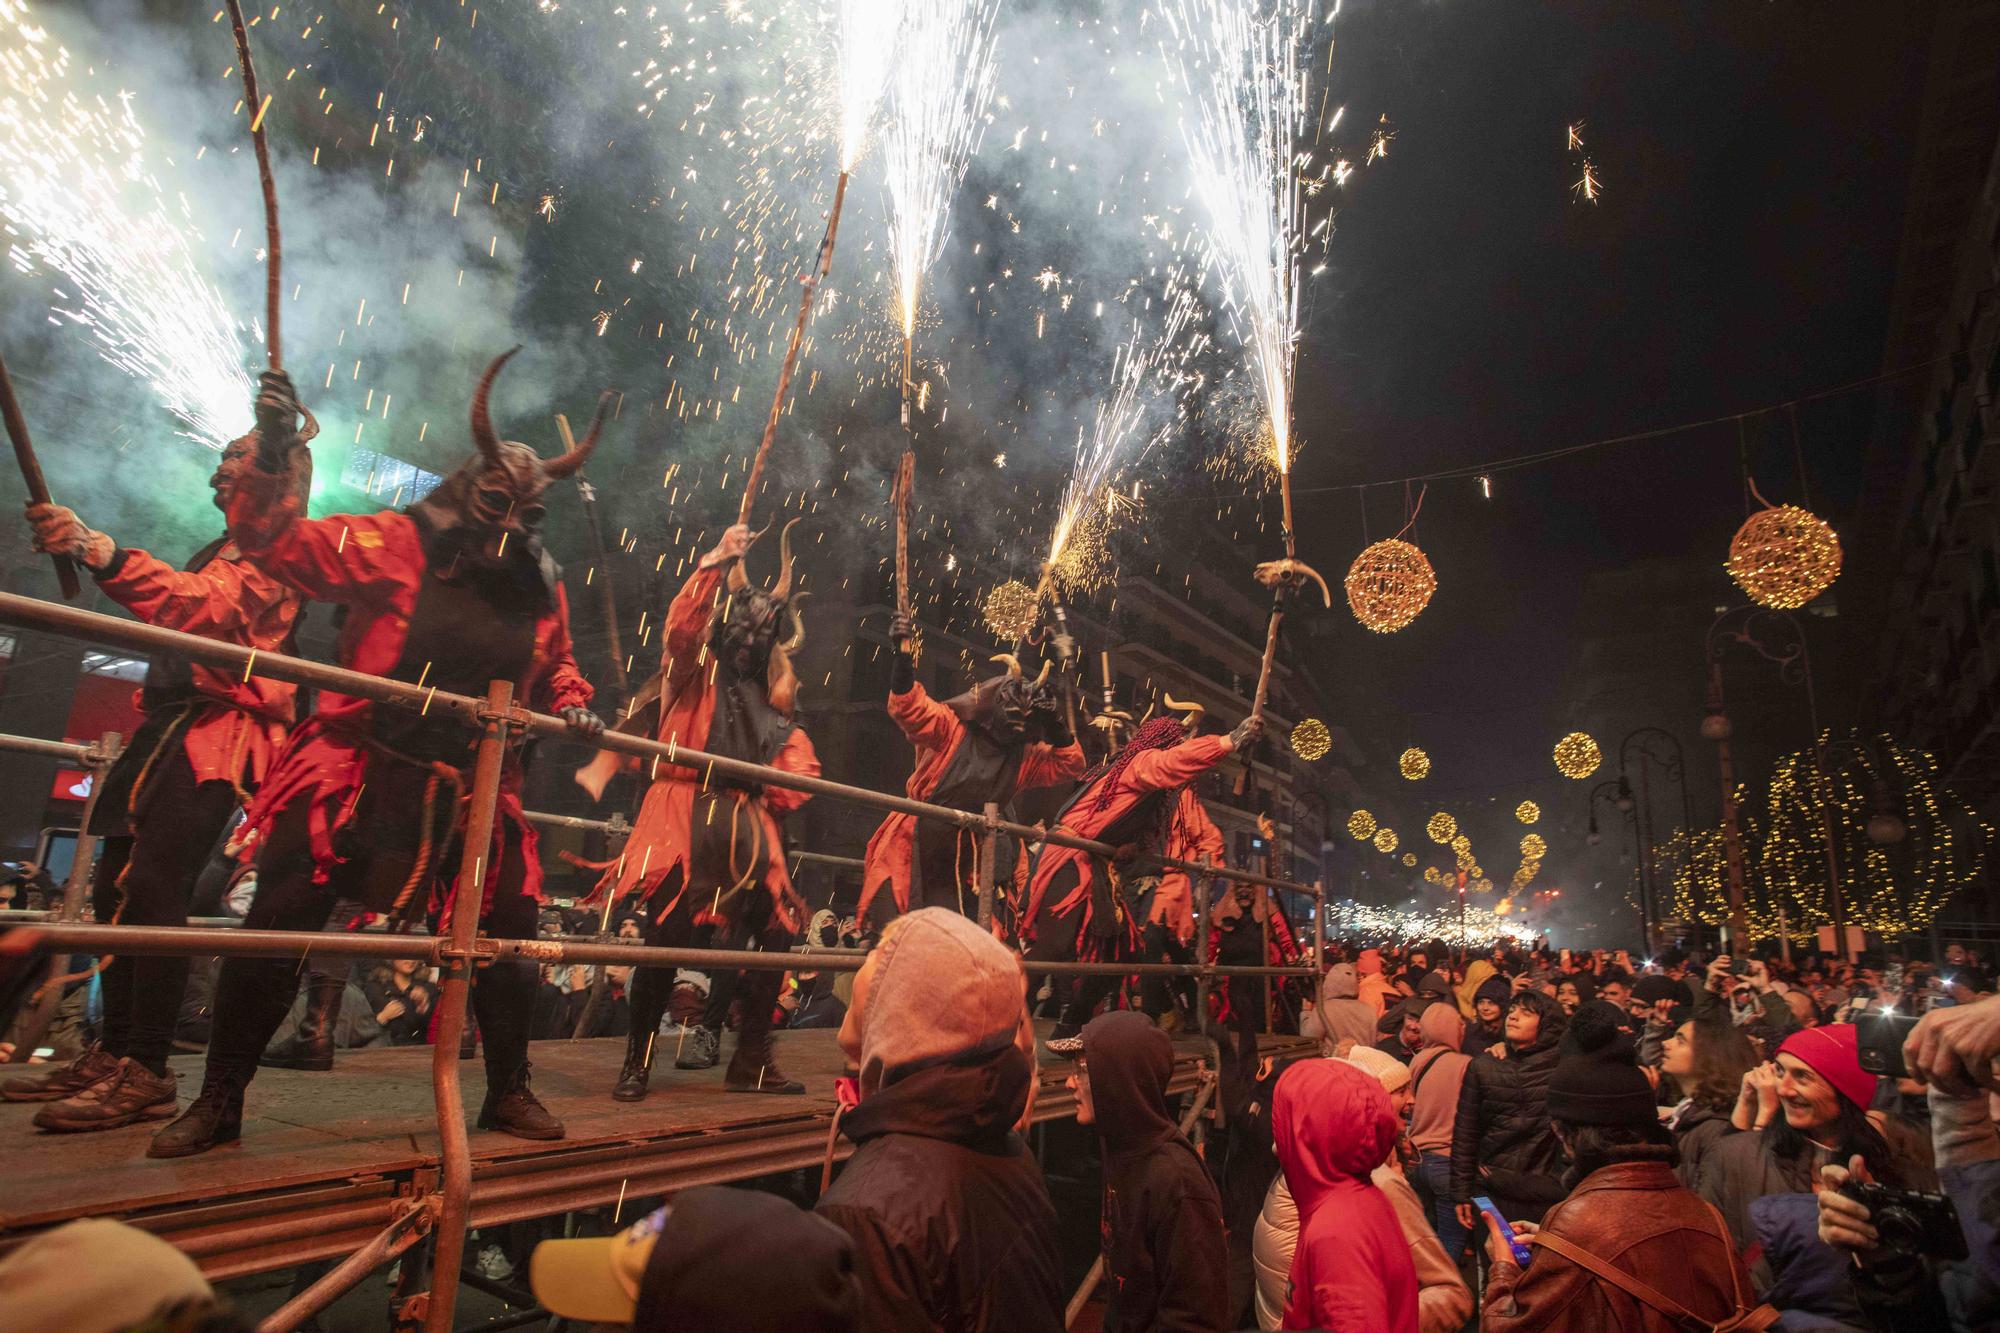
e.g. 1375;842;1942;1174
816;909;1062;1333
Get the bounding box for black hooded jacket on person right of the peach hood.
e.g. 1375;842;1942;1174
1084;1009;1230;1333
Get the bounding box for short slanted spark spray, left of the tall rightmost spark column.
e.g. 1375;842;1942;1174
1048;272;1200;584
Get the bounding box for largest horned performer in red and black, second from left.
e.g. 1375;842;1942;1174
150;348;610;1157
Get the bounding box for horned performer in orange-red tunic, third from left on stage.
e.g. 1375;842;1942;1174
578;518;820;1101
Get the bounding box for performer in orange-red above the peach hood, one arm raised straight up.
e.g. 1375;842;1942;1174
854;616;1084;929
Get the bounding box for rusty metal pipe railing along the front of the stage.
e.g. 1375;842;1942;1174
0;592;1326;1333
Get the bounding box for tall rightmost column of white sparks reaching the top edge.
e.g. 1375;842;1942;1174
1162;0;1314;472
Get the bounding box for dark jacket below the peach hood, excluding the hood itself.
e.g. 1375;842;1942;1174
816;1045;1062;1333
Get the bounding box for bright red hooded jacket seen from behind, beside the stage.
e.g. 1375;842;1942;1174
1272;1061;1418;1333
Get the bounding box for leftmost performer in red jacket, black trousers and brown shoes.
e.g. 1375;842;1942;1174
0;434;304;1131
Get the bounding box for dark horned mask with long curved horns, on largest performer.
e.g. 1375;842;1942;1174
412;346;612;560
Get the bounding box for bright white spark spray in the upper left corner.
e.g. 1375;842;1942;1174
0;0;252;448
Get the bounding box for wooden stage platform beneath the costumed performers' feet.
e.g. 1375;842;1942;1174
0;1025;1318;1279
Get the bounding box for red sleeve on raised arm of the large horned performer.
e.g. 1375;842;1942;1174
228;466;410;602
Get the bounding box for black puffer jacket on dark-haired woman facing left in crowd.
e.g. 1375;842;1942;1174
1452;991;1566;1223
